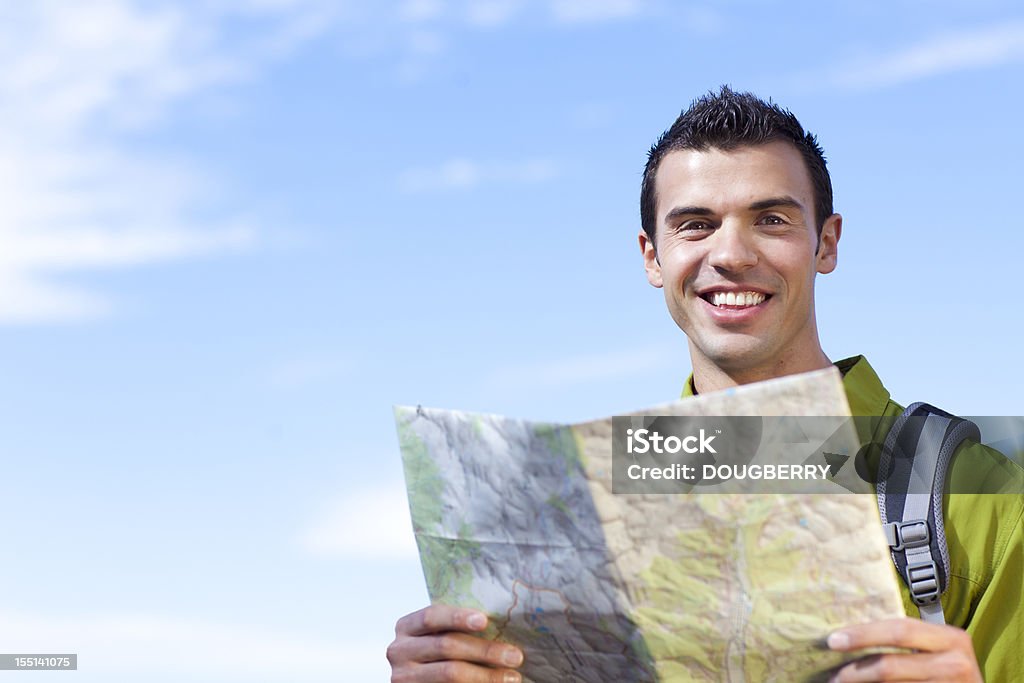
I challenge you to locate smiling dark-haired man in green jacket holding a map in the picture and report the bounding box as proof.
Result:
[388,88,1024,683]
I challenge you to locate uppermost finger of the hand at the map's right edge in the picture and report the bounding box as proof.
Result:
[828,617,974,652]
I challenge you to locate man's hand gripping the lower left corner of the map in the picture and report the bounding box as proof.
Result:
[387,605,522,683]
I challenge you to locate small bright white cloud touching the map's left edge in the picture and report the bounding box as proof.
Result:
[300,483,417,559]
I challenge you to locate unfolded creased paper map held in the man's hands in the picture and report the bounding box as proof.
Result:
[395,369,903,683]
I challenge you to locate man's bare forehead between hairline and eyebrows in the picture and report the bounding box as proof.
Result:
[654,141,814,222]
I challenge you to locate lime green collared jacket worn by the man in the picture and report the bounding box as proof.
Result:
[683,356,1024,683]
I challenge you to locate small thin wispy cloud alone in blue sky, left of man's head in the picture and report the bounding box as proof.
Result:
[398,159,559,193]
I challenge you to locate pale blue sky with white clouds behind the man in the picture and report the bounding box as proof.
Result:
[6,0,1024,682]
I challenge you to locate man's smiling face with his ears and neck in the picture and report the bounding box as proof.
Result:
[640,141,842,381]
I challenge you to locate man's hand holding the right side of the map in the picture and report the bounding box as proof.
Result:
[828,618,981,683]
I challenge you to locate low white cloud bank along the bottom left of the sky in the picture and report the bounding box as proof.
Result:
[0,611,386,681]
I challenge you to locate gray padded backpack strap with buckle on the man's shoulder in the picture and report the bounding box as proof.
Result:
[878,403,981,624]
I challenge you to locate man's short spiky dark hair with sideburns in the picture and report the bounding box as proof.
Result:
[640,85,833,243]
